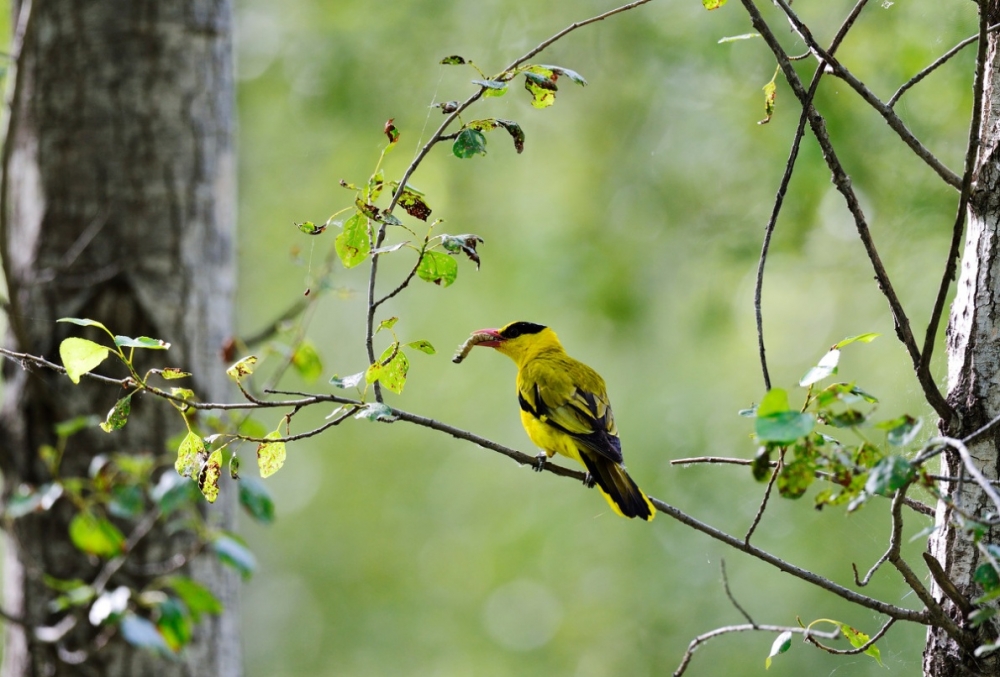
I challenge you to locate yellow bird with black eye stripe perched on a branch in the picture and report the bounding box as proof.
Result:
[470,322,656,520]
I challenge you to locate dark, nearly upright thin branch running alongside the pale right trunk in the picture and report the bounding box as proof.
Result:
[920,11,995,390]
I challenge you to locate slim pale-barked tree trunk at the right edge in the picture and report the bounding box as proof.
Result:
[924,0,1000,677]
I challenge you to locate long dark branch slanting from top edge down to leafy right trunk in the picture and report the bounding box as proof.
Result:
[742,0,952,420]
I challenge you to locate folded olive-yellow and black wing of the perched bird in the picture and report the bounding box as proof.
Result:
[518,380,622,463]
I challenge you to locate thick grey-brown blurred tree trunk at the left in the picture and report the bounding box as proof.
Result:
[0,0,242,677]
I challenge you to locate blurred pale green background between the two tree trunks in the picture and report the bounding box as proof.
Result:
[0,0,975,677]
